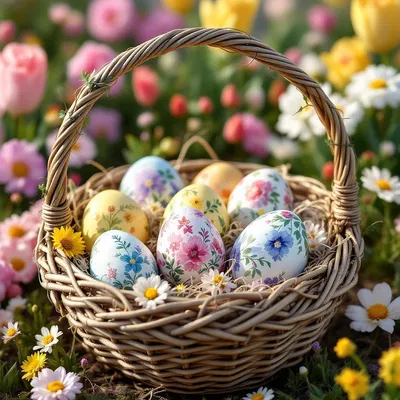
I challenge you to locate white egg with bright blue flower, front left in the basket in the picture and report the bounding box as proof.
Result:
[90,230,158,289]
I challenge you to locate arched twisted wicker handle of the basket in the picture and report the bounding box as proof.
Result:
[42,28,359,231]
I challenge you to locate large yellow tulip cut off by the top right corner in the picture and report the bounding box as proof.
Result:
[351,0,400,53]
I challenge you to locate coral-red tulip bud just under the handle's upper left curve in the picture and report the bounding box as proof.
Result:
[132,66,161,107]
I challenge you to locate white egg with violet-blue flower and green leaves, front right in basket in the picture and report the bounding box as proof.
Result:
[230,210,308,285]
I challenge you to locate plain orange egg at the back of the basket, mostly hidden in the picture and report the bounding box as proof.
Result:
[193,162,244,204]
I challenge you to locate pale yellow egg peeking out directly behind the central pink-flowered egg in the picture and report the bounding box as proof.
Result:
[164,183,229,233]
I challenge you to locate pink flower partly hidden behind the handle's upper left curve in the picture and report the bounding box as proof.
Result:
[67,41,124,96]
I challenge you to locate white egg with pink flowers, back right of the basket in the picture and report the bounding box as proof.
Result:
[228,168,293,228]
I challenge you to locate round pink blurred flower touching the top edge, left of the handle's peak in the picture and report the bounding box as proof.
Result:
[88,0,137,43]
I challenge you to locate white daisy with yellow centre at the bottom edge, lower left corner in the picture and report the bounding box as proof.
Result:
[31,367,83,400]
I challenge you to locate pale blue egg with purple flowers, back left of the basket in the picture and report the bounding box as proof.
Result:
[120,156,184,207]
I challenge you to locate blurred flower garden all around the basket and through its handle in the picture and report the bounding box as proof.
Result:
[0,0,400,400]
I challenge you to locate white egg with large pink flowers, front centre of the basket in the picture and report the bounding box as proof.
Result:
[157,207,225,284]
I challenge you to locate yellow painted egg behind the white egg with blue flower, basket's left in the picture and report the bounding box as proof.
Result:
[82,190,149,251]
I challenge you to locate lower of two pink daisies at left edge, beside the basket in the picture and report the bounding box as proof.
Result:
[0,243,37,283]
